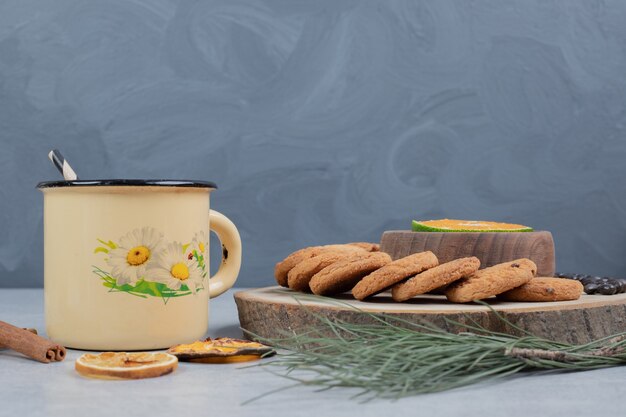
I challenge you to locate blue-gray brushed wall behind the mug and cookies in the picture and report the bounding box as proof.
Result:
[0,0,626,287]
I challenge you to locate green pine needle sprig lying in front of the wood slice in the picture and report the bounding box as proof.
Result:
[244,296,626,399]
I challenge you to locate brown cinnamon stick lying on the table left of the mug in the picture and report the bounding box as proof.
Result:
[0,321,66,363]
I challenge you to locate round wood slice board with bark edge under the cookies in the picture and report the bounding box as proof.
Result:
[235,287,626,344]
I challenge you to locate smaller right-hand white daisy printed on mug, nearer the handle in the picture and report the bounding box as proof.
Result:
[148,242,203,294]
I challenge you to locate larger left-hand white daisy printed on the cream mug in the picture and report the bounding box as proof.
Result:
[107,227,163,285]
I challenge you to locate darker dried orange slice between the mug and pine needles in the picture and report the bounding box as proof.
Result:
[167,337,276,363]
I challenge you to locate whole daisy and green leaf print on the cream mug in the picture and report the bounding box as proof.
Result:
[93,227,208,303]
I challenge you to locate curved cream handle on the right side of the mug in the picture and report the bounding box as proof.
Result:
[209,210,241,298]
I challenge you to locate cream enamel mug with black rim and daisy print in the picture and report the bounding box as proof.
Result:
[37,180,241,350]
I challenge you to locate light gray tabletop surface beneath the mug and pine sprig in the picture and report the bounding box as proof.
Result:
[0,289,626,417]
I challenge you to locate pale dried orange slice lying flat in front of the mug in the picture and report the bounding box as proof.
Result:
[75,352,178,379]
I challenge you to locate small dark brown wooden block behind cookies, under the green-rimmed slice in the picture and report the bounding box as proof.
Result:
[380,230,555,276]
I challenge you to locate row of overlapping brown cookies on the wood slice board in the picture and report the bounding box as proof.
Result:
[274,242,583,303]
